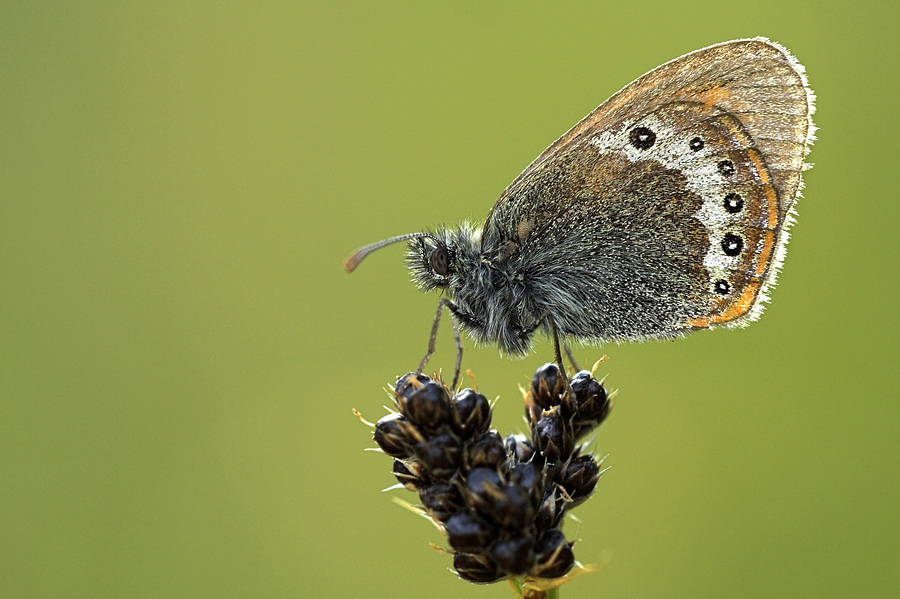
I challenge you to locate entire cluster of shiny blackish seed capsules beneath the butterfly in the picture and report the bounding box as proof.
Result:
[375,364,608,583]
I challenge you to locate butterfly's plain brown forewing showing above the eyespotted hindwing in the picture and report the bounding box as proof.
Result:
[500,37,815,210]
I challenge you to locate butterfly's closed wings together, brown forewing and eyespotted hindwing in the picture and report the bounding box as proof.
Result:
[483,38,814,340]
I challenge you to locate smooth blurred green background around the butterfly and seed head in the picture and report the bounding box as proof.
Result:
[0,0,900,598]
